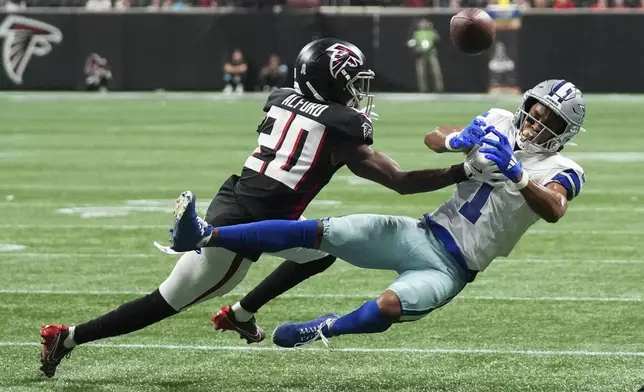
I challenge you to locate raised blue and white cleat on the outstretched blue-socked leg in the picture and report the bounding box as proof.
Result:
[170,191,213,252]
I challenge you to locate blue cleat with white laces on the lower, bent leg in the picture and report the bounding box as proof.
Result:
[273,313,340,348]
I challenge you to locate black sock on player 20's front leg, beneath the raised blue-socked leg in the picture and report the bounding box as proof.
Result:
[239,255,335,313]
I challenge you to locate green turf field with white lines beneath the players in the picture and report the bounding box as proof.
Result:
[0,94,644,392]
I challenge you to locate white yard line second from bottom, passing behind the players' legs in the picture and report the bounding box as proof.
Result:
[0,289,644,302]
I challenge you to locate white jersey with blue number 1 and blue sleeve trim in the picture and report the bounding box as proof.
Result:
[430,109,585,271]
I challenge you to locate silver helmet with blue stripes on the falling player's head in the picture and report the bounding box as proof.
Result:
[514,80,586,153]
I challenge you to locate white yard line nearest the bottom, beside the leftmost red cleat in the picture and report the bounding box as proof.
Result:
[0,341,644,357]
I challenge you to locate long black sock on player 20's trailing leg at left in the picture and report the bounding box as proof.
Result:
[74,289,179,344]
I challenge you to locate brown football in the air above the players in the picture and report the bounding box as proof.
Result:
[449,8,496,55]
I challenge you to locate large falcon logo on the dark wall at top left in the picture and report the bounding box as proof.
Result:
[0,15,63,84]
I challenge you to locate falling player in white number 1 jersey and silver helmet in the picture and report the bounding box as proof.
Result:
[171,80,585,347]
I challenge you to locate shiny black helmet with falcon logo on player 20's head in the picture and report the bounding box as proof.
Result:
[293,38,375,115]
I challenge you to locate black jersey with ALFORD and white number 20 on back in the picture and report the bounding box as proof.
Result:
[206,88,373,259]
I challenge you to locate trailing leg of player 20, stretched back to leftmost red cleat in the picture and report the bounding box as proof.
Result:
[41,248,254,377]
